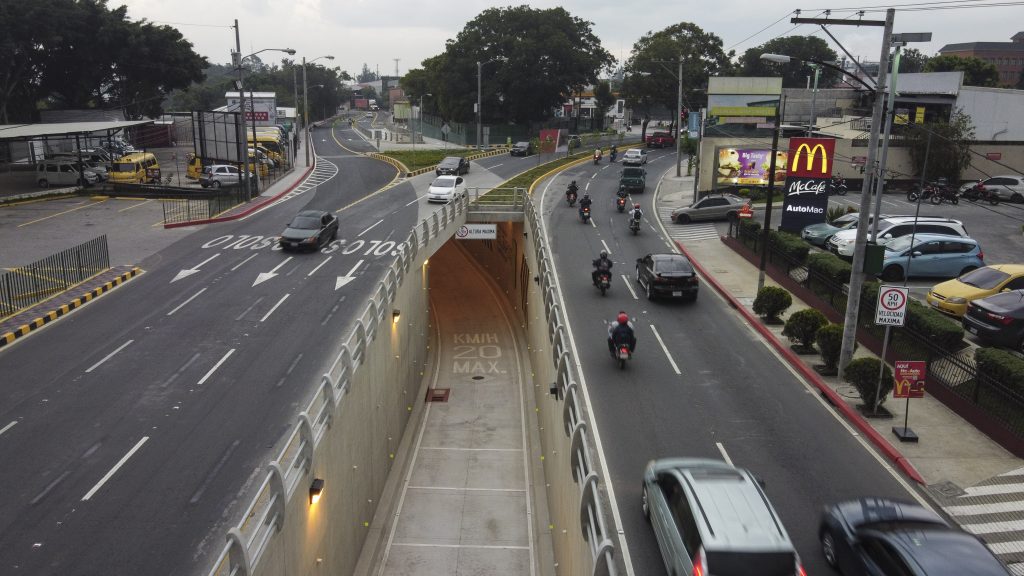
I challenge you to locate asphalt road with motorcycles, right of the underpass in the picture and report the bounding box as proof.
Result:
[535,152,925,576]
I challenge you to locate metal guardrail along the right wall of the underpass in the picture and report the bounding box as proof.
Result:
[524,194,618,576]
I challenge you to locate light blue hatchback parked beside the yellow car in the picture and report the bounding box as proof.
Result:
[881,234,985,282]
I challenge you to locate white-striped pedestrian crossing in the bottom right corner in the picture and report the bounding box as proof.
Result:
[940,468,1024,576]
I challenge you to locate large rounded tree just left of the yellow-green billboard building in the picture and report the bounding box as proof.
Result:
[622,23,733,137]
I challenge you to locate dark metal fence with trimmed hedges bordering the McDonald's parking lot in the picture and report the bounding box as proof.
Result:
[729,223,1024,439]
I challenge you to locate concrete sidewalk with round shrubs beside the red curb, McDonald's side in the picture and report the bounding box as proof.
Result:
[655,171,1024,573]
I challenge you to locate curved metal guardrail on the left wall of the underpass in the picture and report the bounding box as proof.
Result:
[209,196,470,576]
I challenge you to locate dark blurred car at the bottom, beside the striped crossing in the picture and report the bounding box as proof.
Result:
[818,497,1009,576]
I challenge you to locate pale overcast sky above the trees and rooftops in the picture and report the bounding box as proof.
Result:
[117,0,1024,76]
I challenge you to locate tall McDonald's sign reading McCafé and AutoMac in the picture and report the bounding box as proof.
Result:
[779,138,836,234]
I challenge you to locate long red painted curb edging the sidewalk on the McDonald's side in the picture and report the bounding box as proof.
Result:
[675,240,926,485]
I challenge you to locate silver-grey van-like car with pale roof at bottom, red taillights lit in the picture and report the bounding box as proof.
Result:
[641,458,805,576]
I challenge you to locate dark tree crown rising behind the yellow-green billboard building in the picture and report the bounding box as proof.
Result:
[738,36,840,88]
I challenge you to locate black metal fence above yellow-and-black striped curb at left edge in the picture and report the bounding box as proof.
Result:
[0,235,111,318]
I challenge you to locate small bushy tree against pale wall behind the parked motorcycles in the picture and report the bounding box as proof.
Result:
[906,109,974,182]
